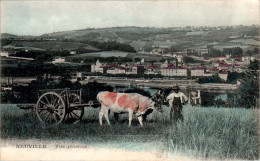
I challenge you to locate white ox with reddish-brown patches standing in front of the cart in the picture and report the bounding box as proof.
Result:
[97,91,161,126]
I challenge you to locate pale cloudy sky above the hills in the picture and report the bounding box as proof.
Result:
[0,0,260,35]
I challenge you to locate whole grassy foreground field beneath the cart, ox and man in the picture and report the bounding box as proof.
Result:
[1,105,260,159]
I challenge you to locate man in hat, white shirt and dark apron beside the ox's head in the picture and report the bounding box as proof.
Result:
[166,85,188,124]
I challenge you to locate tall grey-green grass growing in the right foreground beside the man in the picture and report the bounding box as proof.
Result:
[168,107,260,159]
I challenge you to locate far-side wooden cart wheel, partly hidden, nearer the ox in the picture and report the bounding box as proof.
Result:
[65,93,84,124]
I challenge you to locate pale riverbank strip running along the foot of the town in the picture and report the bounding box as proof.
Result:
[1,77,238,93]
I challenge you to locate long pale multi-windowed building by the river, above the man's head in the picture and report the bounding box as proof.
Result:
[161,67,188,76]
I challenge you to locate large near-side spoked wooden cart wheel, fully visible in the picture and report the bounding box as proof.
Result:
[36,92,66,125]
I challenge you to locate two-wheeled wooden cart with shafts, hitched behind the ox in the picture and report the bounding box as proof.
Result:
[18,88,99,126]
